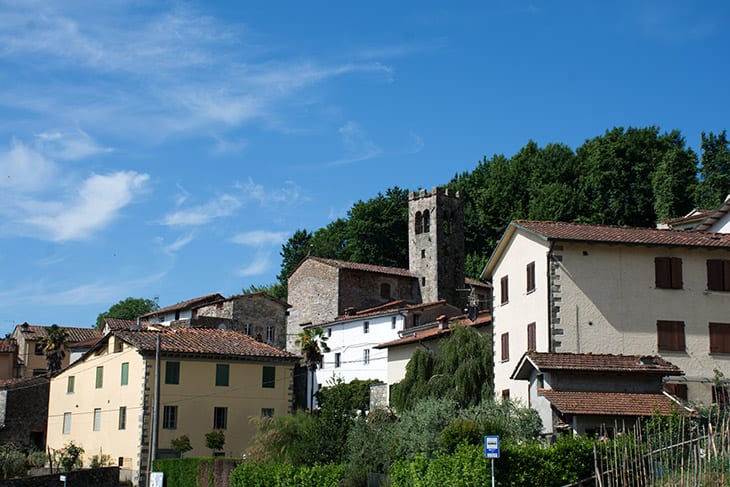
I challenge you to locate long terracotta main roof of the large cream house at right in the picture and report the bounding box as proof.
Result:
[512,220,730,248]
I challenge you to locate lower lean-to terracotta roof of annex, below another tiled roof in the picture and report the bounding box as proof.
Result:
[538,389,678,416]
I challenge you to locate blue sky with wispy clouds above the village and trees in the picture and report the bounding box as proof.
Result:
[0,0,730,335]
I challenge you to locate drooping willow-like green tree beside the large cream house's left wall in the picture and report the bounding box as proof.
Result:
[391,326,493,410]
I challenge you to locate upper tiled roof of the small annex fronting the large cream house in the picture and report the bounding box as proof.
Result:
[512,352,683,379]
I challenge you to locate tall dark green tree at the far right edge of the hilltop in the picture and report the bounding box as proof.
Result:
[696,130,730,208]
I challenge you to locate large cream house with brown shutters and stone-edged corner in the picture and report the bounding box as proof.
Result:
[482,221,730,404]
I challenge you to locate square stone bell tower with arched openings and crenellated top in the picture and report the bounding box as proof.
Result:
[408,188,466,307]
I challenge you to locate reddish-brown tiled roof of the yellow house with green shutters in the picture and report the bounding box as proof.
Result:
[113,328,299,361]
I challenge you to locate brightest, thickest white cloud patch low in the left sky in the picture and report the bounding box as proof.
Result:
[24,171,149,242]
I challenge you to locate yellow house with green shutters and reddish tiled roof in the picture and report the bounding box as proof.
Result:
[47,328,299,485]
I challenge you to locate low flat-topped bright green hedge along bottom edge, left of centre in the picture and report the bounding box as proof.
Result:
[230,462,344,487]
